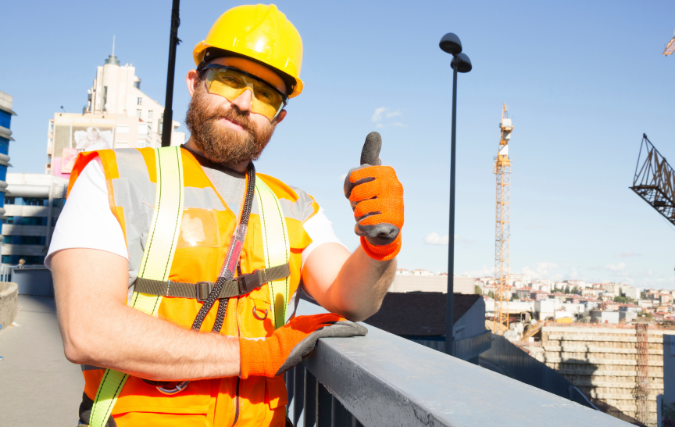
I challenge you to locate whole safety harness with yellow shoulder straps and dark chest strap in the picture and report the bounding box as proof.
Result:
[86,147,290,427]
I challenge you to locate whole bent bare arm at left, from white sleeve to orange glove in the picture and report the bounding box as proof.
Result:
[51,249,240,380]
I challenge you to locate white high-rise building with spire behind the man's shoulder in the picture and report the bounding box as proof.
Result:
[46,46,185,177]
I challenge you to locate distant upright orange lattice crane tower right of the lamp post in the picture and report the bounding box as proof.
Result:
[492,104,513,335]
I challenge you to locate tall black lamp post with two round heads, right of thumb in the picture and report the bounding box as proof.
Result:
[439,33,472,356]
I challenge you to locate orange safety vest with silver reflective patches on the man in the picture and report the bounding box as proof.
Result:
[68,148,319,427]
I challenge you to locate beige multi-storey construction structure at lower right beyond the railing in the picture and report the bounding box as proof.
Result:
[524,319,675,427]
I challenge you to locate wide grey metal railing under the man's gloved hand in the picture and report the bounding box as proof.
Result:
[286,301,630,427]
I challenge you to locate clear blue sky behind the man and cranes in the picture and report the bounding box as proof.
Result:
[0,0,675,289]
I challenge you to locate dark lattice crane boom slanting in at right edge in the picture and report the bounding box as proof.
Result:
[630,133,675,225]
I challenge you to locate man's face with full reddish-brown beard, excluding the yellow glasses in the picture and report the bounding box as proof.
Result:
[185,58,281,165]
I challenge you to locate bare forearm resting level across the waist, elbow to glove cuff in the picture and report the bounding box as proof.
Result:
[60,300,239,380]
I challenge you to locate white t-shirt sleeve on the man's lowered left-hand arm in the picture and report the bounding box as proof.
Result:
[45,159,129,268]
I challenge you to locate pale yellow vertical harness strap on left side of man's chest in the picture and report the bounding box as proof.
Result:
[89,147,184,427]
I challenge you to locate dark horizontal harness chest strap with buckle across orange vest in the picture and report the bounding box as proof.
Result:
[135,263,291,301]
